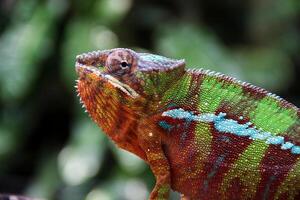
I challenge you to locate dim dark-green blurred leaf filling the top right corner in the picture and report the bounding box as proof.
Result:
[247,0,300,52]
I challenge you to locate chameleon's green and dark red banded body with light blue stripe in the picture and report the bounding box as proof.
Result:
[155,70,300,199]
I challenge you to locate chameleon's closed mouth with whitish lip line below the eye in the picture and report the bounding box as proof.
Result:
[75,62,139,98]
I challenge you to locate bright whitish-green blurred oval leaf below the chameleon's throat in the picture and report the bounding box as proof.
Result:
[58,120,106,185]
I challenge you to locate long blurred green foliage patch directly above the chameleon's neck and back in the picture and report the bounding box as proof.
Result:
[156,24,293,91]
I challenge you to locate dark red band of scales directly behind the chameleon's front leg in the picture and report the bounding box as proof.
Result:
[155,111,198,191]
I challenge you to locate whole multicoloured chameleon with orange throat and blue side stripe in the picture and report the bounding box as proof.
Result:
[75,48,300,200]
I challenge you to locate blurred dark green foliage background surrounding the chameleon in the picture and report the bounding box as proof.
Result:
[0,0,300,200]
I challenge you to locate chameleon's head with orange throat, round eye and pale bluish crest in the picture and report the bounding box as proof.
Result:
[75,48,185,138]
